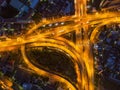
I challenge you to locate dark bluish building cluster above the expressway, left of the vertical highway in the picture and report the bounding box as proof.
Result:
[0,0,74,36]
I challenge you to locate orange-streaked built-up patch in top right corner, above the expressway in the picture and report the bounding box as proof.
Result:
[87,0,120,13]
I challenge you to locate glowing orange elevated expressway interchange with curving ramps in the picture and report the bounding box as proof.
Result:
[0,0,120,90]
